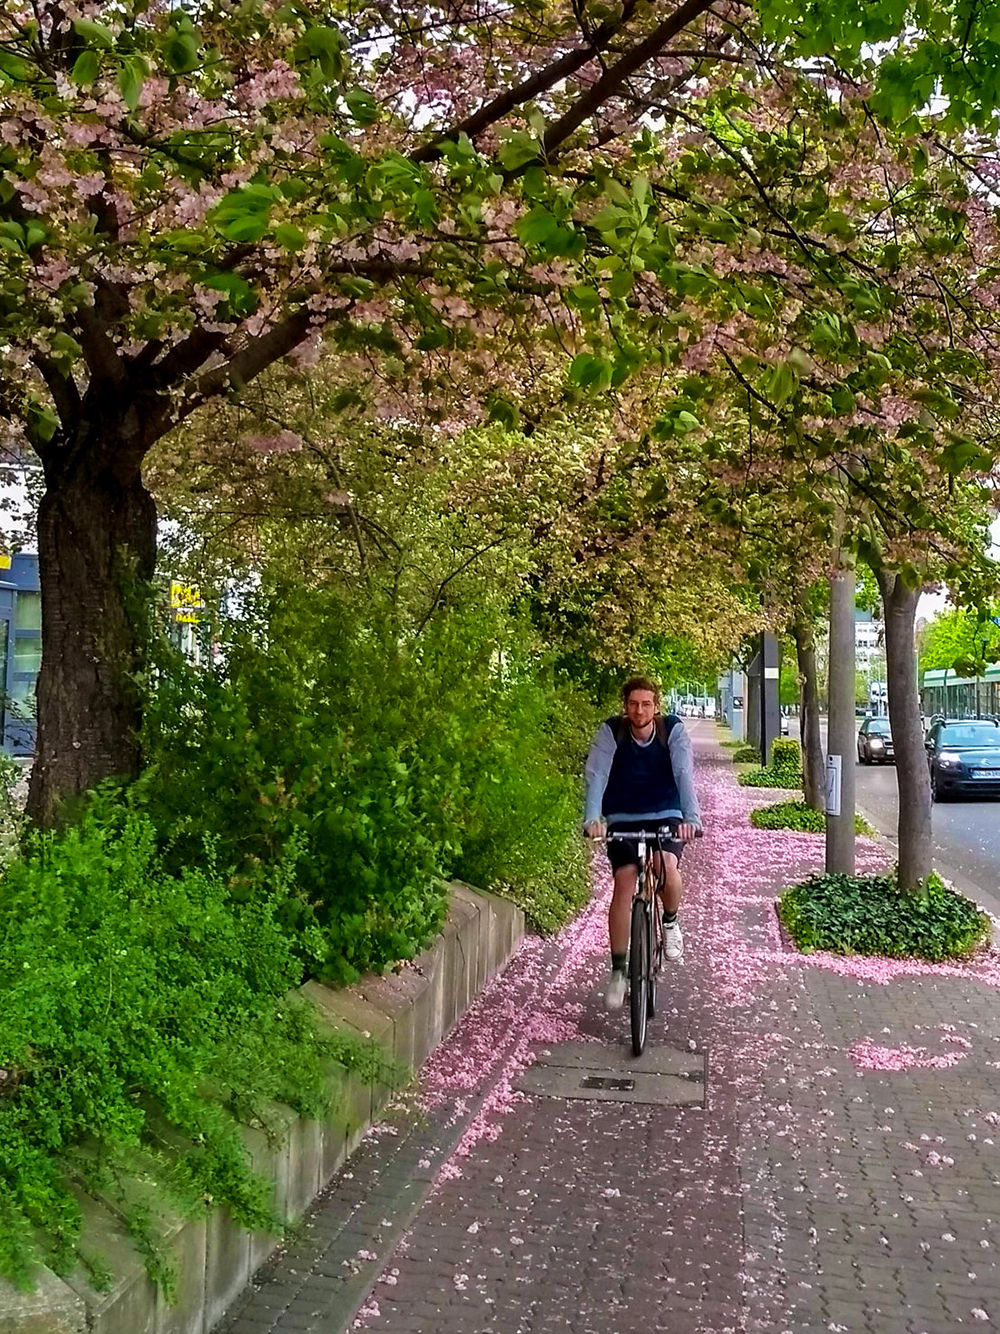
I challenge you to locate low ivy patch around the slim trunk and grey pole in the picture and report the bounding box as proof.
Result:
[777,875,989,963]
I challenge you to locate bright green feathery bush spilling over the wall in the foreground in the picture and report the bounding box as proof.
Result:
[0,794,373,1283]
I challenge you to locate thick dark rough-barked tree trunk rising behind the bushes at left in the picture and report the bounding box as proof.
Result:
[28,464,156,827]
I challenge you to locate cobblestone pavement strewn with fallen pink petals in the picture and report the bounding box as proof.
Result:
[223,723,1000,1334]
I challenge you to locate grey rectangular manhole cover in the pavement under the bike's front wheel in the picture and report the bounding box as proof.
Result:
[513,1042,705,1107]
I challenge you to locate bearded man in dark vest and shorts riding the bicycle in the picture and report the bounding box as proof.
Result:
[584,676,701,1010]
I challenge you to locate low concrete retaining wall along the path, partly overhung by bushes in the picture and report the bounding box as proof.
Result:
[0,883,524,1334]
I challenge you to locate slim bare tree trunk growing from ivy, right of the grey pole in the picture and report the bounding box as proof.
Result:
[876,571,932,890]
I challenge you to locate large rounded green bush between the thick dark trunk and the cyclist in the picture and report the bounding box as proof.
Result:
[143,586,593,982]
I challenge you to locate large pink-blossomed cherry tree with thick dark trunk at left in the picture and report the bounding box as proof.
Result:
[0,0,996,823]
